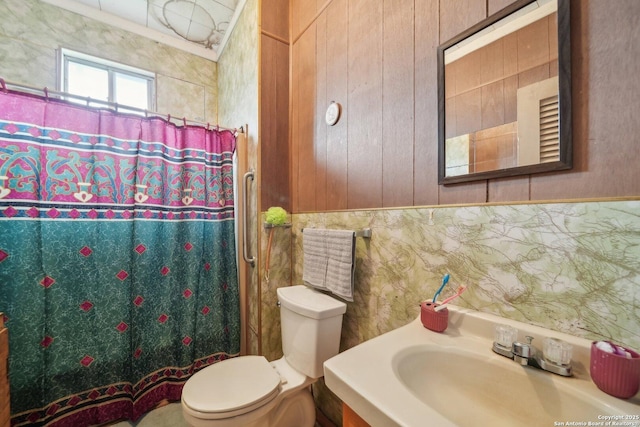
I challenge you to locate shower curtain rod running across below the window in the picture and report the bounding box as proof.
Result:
[0,77,244,133]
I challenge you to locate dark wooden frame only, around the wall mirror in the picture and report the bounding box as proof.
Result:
[438,0,573,185]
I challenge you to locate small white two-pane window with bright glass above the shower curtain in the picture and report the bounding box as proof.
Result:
[60,49,155,113]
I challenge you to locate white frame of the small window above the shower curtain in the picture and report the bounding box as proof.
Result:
[58,48,156,111]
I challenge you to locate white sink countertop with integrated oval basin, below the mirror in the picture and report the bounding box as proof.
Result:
[324,307,640,427]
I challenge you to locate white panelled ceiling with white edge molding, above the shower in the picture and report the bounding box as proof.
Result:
[43,0,246,61]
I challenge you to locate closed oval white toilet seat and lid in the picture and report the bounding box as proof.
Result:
[182,356,280,419]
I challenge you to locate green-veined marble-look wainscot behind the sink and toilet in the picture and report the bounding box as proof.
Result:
[264,200,640,421]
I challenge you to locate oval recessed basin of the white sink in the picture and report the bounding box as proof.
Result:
[393,345,604,426]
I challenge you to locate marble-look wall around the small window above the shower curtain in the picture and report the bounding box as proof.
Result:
[0,0,218,126]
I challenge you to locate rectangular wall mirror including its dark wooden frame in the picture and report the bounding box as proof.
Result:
[438,0,572,184]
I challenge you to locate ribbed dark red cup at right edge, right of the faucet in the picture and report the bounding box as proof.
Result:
[590,341,640,399]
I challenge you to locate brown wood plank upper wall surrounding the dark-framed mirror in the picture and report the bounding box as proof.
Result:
[290,0,640,212]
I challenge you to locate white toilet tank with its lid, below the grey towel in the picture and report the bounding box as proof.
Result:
[277,285,347,378]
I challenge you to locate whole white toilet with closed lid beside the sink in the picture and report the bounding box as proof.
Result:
[182,285,347,427]
